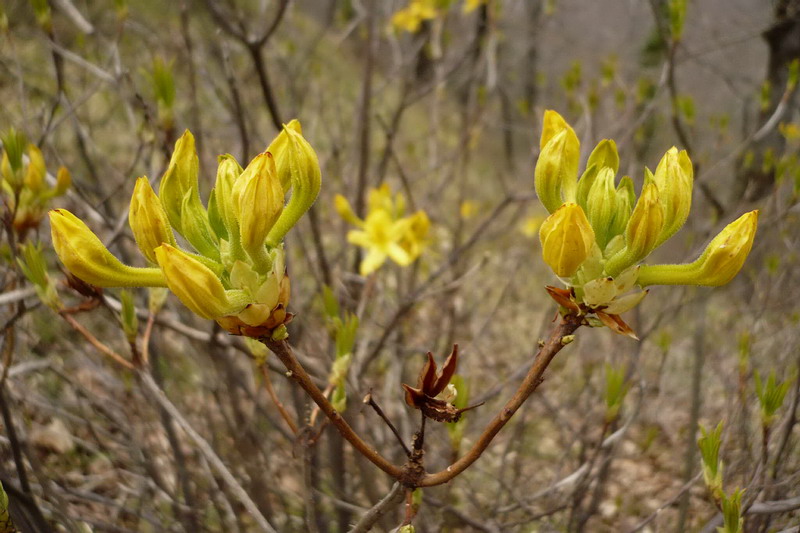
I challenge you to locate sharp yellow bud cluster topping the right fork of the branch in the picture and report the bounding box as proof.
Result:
[535,111,758,331]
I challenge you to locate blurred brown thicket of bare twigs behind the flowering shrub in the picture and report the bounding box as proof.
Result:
[0,0,800,532]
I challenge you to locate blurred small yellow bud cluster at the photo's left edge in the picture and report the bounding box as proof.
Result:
[0,129,72,240]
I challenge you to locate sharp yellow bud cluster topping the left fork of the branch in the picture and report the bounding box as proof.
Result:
[50,121,320,337]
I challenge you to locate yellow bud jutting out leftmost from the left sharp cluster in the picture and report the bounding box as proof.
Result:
[50,209,166,287]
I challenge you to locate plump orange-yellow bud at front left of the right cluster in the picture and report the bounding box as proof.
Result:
[539,203,594,278]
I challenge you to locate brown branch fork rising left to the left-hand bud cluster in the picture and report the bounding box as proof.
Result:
[259,337,403,479]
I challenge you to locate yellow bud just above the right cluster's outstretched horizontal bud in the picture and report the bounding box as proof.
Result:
[606,183,664,276]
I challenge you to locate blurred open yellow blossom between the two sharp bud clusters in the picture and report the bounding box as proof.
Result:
[334,183,431,276]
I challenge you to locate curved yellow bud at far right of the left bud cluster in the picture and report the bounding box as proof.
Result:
[267,126,322,247]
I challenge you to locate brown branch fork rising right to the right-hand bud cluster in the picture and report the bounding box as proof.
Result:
[417,315,582,487]
